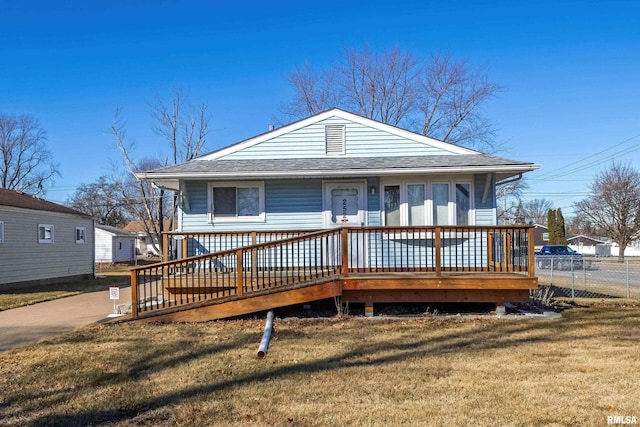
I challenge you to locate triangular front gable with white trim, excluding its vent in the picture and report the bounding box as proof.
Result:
[201,108,480,160]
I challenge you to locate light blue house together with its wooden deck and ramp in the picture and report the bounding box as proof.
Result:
[132,109,539,320]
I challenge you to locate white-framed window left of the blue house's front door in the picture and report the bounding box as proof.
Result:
[209,182,264,222]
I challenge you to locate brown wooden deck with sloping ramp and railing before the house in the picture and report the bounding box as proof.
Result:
[132,227,538,321]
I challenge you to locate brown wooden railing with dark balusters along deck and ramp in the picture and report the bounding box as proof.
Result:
[131,226,535,317]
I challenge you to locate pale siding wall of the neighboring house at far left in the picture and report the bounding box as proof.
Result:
[0,206,94,285]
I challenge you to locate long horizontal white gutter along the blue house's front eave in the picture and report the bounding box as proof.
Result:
[136,165,540,183]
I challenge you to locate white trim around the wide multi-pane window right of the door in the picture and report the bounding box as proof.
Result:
[380,179,476,227]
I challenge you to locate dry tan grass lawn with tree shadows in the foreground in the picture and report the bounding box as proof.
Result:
[0,305,640,426]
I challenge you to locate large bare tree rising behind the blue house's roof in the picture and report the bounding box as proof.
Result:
[282,47,501,151]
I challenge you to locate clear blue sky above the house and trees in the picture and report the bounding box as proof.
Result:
[0,0,640,217]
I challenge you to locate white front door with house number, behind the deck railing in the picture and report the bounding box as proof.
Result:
[323,181,368,268]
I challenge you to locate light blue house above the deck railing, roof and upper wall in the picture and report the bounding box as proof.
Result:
[138,109,539,231]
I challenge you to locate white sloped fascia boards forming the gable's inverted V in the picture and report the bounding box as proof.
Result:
[196,108,483,160]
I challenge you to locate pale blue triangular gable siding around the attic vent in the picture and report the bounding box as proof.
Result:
[220,117,453,160]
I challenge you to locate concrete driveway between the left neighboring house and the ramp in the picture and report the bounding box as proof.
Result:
[0,287,131,352]
